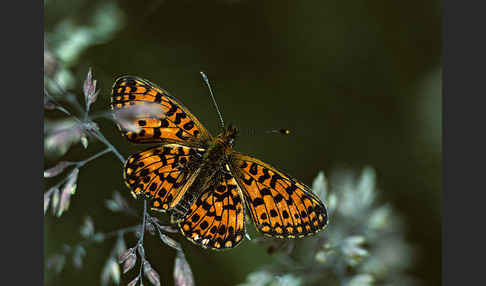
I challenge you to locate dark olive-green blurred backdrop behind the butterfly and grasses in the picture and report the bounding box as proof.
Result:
[44,1,442,285]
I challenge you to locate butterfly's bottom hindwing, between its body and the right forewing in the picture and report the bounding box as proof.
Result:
[179,168,245,250]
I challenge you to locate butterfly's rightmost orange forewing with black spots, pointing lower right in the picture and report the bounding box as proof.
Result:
[230,152,327,238]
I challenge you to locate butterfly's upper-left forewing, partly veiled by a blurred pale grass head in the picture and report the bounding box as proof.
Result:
[111,76,211,146]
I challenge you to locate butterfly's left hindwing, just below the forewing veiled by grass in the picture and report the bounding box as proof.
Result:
[124,144,205,211]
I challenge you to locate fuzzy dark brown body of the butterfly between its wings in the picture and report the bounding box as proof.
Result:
[172,126,238,221]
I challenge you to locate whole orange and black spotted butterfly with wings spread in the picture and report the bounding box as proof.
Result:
[111,74,327,249]
